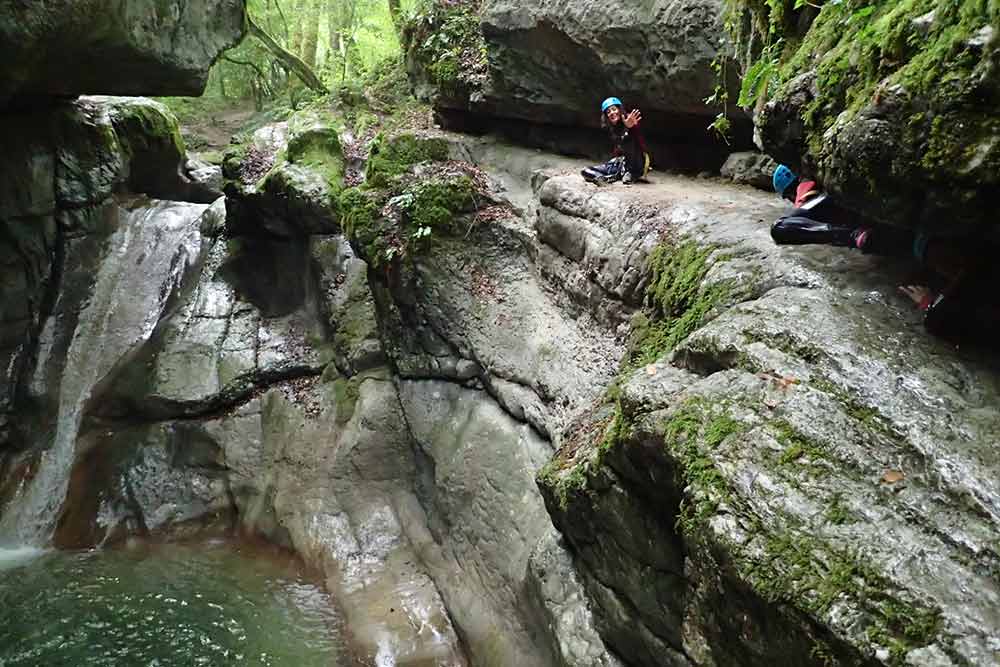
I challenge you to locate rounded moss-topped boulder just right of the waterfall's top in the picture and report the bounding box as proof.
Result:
[223,111,344,237]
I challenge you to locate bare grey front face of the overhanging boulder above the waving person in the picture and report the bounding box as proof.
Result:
[482,0,736,125]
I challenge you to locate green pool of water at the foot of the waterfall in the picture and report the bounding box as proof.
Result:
[0,541,351,667]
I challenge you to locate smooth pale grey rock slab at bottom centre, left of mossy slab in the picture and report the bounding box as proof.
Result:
[392,381,552,666]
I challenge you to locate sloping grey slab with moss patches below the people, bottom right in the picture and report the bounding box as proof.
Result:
[539,168,1000,665]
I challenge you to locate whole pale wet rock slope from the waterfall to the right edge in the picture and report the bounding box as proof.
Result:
[0,107,1000,666]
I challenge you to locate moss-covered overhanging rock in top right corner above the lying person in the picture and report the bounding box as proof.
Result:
[744,0,1000,233]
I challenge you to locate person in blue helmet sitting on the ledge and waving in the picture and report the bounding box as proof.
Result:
[580,97,650,185]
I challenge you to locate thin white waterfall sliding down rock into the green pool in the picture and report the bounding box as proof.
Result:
[0,200,208,548]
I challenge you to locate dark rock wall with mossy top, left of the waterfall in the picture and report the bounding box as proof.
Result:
[0,97,204,448]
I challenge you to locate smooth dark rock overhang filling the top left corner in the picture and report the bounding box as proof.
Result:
[0,0,246,108]
